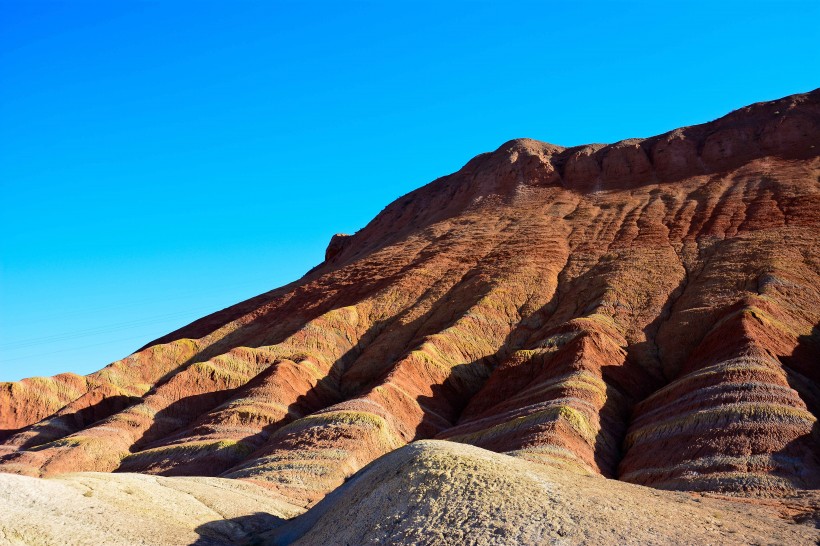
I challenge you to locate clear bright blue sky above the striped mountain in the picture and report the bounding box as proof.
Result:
[0,0,820,381]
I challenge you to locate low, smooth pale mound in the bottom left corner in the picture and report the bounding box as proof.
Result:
[0,472,302,546]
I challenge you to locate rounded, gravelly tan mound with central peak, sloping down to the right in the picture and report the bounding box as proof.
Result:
[266,440,820,546]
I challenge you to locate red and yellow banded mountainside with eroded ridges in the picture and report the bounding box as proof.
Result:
[0,91,820,536]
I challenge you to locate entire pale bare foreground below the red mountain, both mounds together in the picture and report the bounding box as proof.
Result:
[0,440,820,546]
